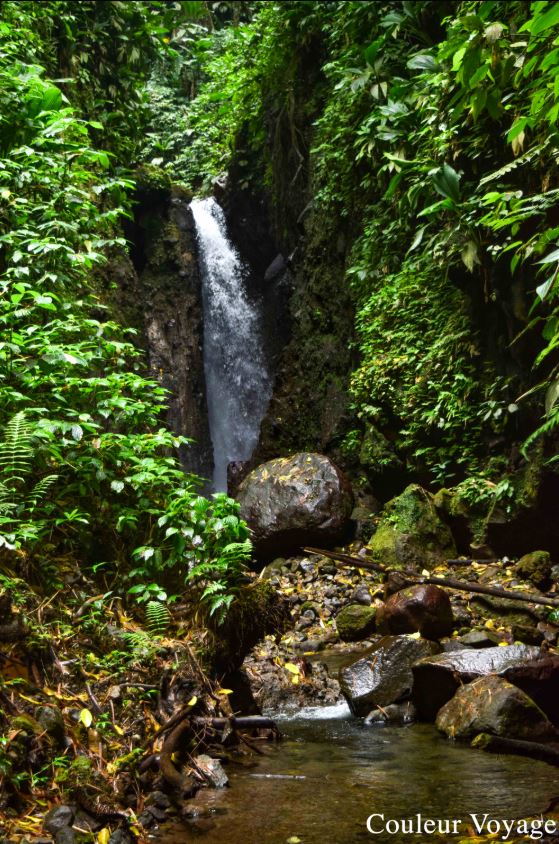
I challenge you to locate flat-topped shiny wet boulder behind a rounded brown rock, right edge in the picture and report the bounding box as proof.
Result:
[412,645,559,723]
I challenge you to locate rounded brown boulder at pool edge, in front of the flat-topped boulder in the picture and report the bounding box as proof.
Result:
[436,674,557,741]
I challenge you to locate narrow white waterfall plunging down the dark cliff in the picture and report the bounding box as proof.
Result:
[191,198,272,490]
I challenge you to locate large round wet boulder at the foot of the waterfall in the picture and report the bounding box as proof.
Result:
[237,452,353,556]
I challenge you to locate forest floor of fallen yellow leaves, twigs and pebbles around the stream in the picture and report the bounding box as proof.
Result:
[0,543,559,844]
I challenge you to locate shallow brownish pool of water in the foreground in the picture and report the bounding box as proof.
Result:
[154,705,559,844]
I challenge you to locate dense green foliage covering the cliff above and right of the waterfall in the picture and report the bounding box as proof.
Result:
[146,2,559,481]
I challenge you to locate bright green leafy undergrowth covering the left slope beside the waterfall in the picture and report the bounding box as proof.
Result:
[0,2,249,612]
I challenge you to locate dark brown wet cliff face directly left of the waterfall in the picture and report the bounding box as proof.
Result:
[118,178,213,477]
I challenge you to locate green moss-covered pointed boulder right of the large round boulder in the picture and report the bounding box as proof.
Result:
[369,484,456,568]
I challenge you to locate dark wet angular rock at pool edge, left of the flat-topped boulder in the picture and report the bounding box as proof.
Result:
[340,636,438,716]
